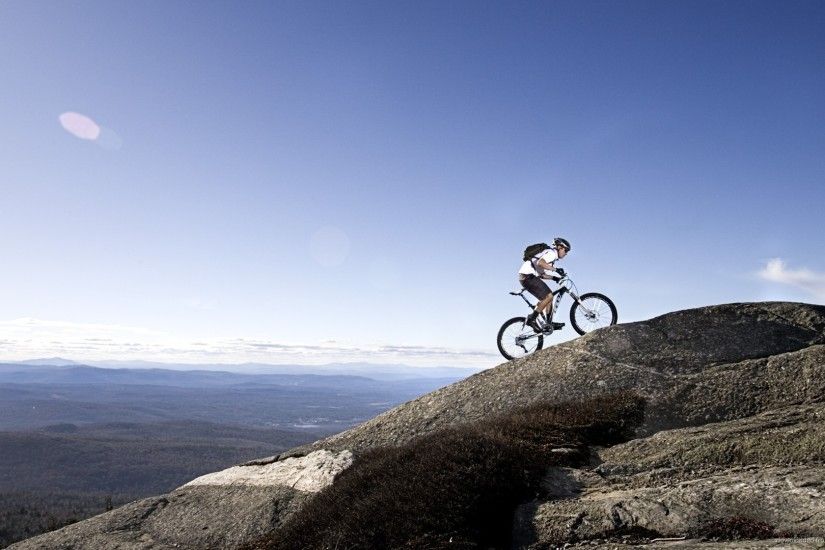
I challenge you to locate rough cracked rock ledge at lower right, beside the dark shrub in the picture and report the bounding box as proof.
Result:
[516,404,825,548]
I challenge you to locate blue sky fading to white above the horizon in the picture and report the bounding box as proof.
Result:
[0,0,825,366]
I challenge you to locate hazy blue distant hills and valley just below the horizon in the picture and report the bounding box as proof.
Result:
[0,360,475,432]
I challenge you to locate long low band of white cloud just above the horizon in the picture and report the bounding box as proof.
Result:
[0,318,500,367]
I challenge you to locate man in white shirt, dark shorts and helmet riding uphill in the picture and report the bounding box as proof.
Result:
[518,237,570,332]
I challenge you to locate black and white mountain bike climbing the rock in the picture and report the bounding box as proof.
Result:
[497,274,619,360]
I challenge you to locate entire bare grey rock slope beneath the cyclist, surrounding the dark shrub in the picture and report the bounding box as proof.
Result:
[13,302,825,549]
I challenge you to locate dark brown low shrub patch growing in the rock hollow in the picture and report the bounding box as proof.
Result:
[245,393,644,550]
